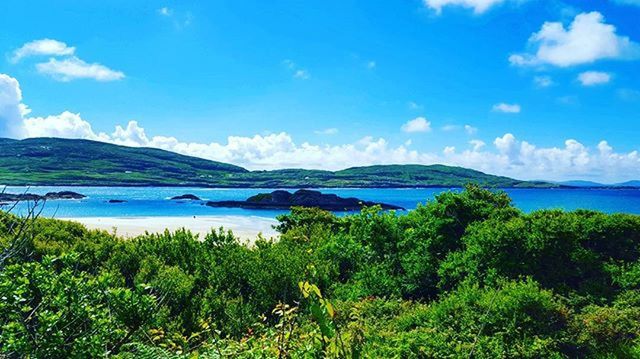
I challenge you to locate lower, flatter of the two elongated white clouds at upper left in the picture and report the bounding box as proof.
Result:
[36,56,124,82]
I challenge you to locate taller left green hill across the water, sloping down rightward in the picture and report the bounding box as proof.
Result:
[0,138,247,185]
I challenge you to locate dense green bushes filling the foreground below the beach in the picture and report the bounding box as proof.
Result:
[0,187,640,358]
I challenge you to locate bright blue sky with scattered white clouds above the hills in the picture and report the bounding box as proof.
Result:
[0,0,640,182]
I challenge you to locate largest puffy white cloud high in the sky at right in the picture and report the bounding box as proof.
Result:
[509,11,640,67]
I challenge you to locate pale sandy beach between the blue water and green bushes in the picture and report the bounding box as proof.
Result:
[59,216,278,241]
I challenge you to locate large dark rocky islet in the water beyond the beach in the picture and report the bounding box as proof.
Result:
[206,189,404,211]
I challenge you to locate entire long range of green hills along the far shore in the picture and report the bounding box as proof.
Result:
[0,138,559,188]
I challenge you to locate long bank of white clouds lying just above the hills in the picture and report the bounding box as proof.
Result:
[0,74,640,182]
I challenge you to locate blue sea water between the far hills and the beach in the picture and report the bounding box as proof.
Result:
[6,187,640,218]
